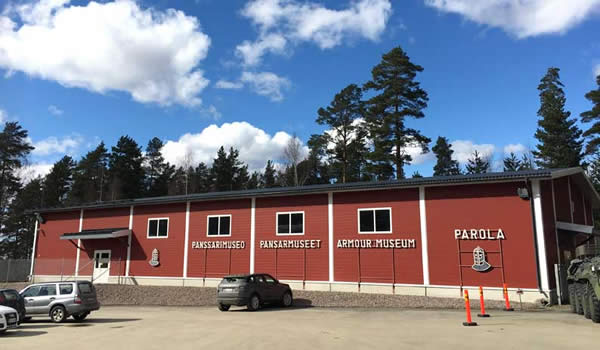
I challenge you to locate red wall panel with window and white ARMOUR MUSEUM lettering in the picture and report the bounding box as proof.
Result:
[333,188,423,284]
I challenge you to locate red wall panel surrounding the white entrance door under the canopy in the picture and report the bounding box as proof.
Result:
[79,207,129,276]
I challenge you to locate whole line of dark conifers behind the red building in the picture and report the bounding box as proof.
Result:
[0,47,600,257]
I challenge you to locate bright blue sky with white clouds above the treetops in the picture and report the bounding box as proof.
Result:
[0,0,600,179]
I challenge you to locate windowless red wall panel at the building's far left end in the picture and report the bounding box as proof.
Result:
[34,210,80,276]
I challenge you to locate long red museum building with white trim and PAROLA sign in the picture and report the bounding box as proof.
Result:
[31,168,600,301]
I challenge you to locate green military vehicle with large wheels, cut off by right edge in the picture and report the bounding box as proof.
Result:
[567,243,600,323]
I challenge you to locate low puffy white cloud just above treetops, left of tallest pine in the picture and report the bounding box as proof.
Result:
[162,122,308,171]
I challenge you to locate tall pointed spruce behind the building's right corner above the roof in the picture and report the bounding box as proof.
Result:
[533,68,583,168]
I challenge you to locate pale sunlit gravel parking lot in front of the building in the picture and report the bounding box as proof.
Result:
[0,306,600,350]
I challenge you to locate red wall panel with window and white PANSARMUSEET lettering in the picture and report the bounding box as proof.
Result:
[255,194,329,281]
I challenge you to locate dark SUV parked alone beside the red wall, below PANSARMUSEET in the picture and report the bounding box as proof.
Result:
[217,273,293,311]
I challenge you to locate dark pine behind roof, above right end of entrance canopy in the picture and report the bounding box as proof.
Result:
[109,136,144,199]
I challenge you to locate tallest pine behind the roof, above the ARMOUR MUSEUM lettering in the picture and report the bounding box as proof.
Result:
[364,47,431,180]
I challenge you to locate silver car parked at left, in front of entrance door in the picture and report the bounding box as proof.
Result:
[20,281,100,323]
